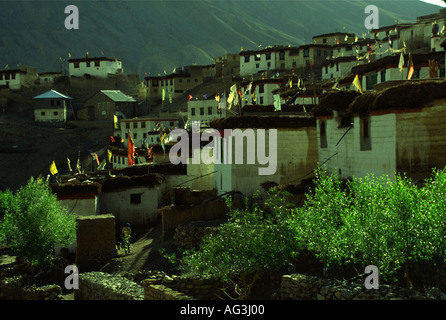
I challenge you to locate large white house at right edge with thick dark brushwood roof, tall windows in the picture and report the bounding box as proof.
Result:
[314,80,446,180]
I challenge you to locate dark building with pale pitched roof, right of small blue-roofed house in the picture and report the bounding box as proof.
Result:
[77,90,138,120]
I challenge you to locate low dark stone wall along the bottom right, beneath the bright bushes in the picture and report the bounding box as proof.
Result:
[280,274,446,300]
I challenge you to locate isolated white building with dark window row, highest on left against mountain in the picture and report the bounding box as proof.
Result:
[68,54,124,78]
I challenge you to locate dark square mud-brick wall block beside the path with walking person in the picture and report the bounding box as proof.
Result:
[76,214,118,272]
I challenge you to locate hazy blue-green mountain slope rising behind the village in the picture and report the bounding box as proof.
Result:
[0,0,438,76]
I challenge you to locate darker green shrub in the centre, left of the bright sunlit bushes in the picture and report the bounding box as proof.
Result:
[180,192,299,297]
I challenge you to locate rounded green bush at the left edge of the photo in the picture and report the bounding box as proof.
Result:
[0,178,76,265]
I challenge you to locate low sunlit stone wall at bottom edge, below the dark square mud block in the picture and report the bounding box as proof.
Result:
[74,272,144,300]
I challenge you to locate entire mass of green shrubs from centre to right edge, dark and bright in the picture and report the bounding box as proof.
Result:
[181,169,446,296]
